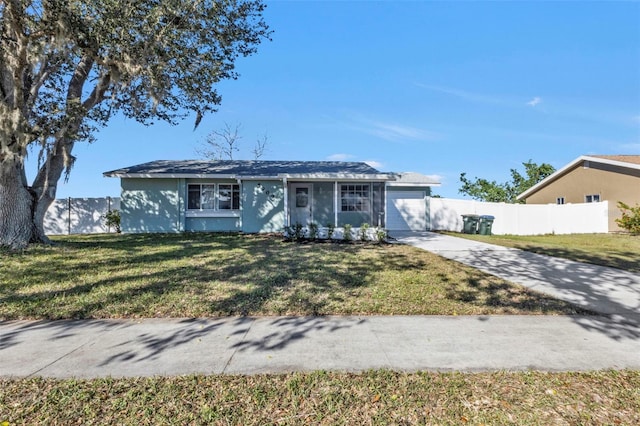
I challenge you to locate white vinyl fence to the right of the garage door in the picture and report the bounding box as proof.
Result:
[428,198,609,235]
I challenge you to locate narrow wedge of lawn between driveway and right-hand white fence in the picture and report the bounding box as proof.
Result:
[447,232,640,273]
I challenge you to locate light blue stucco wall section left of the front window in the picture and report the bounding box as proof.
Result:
[120,178,182,233]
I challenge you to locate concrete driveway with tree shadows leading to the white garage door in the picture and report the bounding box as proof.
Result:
[393,232,640,322]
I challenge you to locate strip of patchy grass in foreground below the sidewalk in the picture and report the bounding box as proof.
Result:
[0,370,640,425]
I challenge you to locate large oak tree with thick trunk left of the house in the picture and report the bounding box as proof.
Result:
[0,0,269,249]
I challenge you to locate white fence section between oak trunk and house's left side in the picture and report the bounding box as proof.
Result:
[44,197,120,235]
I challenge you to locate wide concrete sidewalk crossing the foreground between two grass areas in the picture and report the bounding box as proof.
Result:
[0,316,640,378]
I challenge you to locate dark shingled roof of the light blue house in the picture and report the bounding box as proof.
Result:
[104,160,394,180]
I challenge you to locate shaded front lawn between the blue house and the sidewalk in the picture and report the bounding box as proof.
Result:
[0,233,584,320]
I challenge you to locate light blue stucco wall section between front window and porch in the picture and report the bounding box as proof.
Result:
[241,180,285,233]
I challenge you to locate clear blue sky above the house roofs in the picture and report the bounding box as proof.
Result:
[28,1,640,198]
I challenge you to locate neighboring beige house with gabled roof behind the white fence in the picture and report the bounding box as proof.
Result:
[518,155,640,232]
